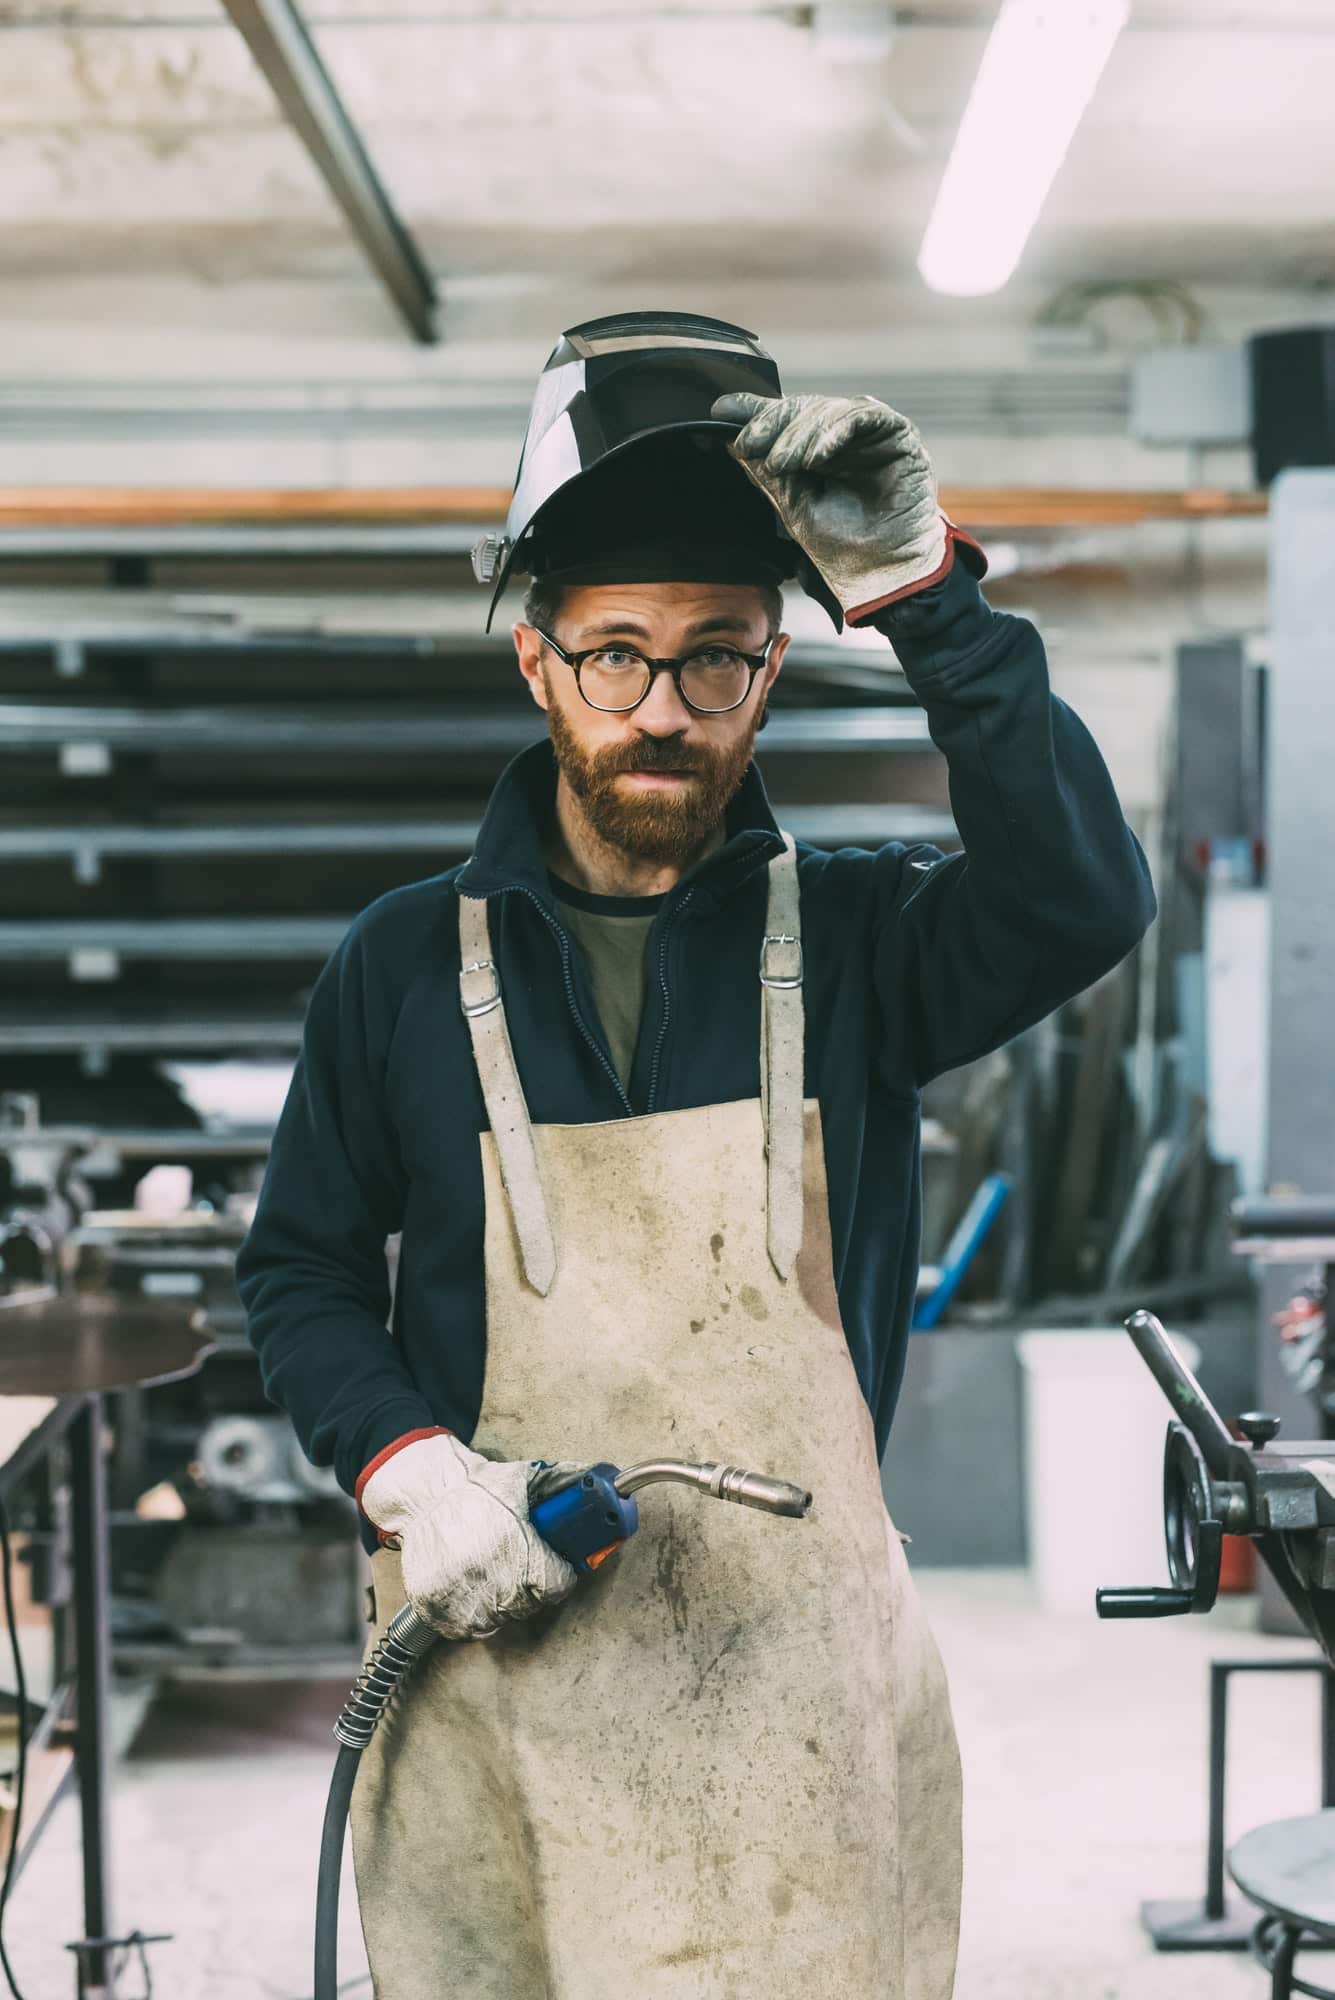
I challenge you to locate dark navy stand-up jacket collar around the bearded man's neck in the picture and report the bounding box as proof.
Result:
[456,740,783,908]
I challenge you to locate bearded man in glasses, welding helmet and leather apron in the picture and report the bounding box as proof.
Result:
[240,316,1155,2000]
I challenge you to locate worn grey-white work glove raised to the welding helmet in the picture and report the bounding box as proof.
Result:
[709,394,981,624]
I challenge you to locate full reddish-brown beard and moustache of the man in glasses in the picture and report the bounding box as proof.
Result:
[548,682,765,868]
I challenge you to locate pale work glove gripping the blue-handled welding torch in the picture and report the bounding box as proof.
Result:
[356,1430,584,1638]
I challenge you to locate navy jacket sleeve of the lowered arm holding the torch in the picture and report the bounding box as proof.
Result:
[236,920,434,1492]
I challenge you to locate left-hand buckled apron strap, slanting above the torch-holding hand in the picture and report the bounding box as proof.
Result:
[460,896,556,1298]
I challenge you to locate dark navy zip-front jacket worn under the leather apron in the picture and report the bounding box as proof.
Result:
[238,562,1155,1546]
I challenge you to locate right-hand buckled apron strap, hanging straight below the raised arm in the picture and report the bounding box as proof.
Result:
[759,834,803,1278]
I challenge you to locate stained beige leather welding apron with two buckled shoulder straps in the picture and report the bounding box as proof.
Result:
[352,842,959,2000]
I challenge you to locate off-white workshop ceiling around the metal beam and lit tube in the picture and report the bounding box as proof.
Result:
[0,0,1335,298]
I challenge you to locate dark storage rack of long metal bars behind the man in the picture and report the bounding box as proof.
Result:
[0,526,955,1088]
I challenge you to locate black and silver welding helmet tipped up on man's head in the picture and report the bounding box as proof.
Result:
[474,312,843,630]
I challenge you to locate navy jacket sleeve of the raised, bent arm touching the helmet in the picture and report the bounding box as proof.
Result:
[873,562,1157,1084]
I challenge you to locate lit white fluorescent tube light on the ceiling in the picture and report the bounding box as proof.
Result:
[917,0,1129,296]
